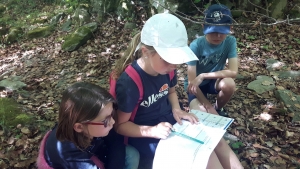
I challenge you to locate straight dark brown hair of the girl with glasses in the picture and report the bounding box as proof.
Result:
[56,82,115,149]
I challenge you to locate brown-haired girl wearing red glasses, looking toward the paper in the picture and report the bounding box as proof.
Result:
[37,82,139,169]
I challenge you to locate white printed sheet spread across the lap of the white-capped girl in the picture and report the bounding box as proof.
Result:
[153,110,233,169]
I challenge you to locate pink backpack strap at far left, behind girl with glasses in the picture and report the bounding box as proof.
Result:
[36,131,53,169]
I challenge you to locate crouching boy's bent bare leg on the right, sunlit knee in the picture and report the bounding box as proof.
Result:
[215,78,235,109]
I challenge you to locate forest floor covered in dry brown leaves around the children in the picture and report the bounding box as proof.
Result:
[0,1,300,169]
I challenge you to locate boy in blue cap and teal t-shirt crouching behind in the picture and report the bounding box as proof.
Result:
[185,4,238,116]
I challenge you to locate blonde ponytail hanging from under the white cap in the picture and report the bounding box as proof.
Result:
[113,32,156,78]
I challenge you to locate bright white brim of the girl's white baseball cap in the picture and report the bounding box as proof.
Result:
[154,46,198,64]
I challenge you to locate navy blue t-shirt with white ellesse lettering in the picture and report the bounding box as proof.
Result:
[116,61,177,125]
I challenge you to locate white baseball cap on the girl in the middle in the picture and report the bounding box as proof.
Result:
[141,13,198,64]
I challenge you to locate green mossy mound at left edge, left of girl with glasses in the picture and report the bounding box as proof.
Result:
[0,98,31,128]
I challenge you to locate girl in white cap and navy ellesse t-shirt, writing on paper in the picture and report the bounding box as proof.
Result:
[115,14,243,169]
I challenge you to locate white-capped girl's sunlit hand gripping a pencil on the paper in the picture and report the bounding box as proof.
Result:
[151,122,173,139]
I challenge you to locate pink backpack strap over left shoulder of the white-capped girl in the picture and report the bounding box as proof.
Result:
[124,65,144,145]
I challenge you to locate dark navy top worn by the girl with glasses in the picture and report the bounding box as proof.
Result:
[44,126,125,169]
